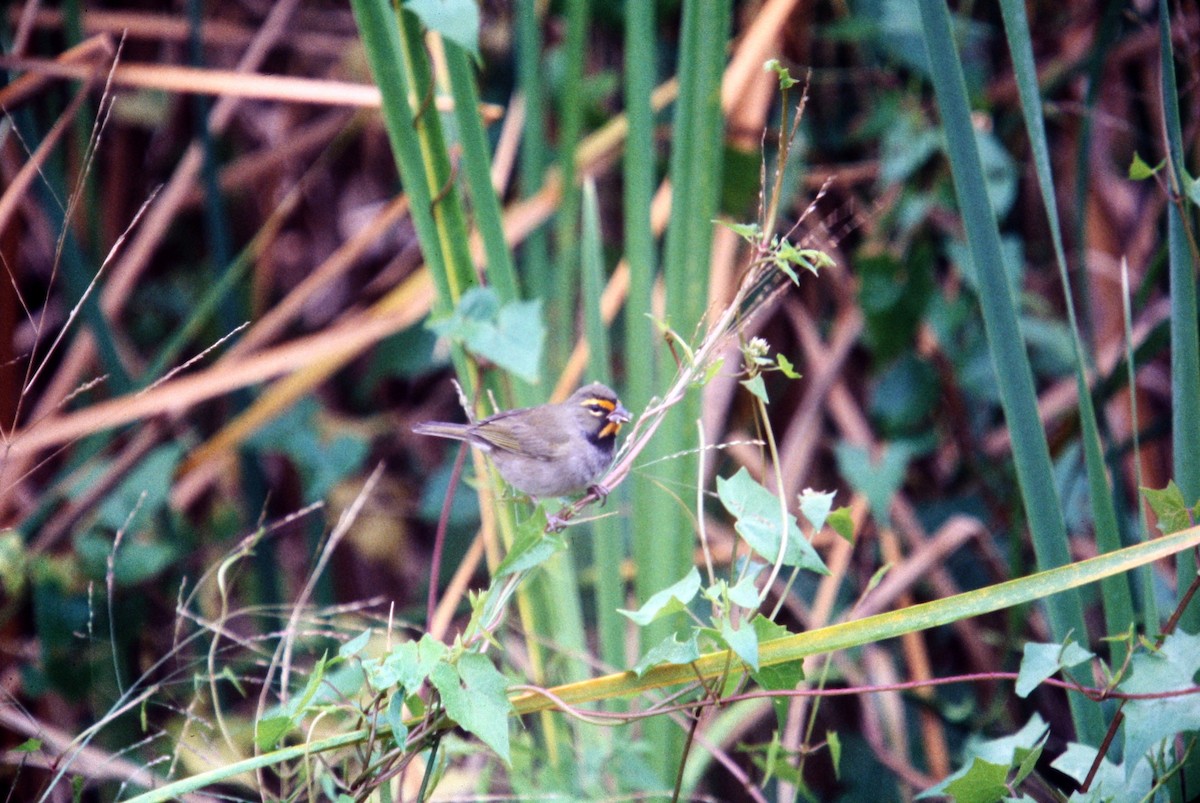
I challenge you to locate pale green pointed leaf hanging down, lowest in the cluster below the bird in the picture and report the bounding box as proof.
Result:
[430,653,512,763]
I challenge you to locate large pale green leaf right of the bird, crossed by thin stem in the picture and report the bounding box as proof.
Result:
[716,468,829,574]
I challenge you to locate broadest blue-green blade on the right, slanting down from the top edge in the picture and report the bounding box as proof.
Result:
[920,0,1104,744]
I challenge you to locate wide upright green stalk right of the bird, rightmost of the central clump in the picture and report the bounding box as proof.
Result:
[634,0,732,779]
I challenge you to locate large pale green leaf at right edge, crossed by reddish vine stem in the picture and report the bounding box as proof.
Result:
[1120,630,1200,762]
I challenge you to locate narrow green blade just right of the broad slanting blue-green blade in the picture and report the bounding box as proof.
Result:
[1001,0,1132,665]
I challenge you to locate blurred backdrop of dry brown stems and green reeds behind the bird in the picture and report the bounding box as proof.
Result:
[0,0,1200,801]
